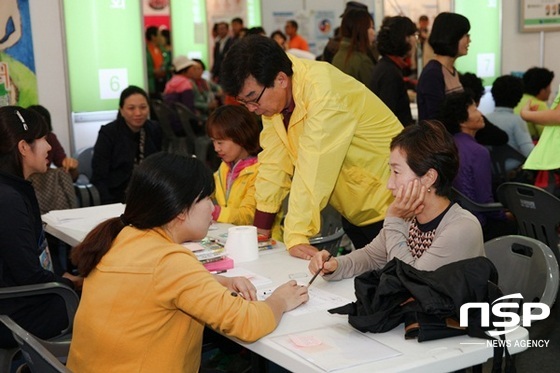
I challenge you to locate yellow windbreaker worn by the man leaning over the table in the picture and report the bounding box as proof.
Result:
[255,56,402,248]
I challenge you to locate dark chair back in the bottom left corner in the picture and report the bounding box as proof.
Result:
[0,315,70,373]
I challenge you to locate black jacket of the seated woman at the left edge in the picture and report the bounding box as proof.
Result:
[0,172,73,348]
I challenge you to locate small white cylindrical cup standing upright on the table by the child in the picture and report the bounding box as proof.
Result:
[225,225,259,263]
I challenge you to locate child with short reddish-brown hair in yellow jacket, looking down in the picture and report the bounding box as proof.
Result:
[206,105,282,240]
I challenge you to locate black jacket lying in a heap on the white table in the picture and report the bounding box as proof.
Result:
[329,257,498,336]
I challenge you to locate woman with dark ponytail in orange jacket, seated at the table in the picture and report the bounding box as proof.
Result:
[68,153,308,372]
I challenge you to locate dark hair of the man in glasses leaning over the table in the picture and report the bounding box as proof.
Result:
[220,35,294,97]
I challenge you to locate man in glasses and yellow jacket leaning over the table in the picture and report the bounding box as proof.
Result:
[221,36,402,259]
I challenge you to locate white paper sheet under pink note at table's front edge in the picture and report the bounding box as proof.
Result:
[272,324,402,372]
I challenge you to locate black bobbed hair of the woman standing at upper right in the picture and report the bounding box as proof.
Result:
[428,12,471,57]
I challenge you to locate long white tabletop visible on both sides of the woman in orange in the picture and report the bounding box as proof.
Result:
[43,204,529,372]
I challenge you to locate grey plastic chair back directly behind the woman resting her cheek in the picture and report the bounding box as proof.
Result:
[484,235,559,320]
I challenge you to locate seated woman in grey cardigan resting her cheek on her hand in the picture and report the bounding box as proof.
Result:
[309,121,485,280]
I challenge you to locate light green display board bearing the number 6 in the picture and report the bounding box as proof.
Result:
[64,0,146,112]
